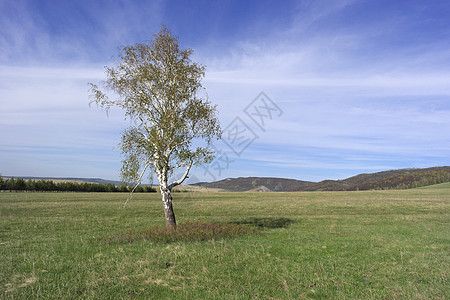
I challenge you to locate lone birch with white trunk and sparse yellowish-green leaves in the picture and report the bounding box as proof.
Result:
[89,25,221,228]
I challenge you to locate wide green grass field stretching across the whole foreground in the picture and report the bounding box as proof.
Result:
[0,184,450,299]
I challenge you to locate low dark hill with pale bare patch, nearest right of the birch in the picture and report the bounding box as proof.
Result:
[193,177,313,192]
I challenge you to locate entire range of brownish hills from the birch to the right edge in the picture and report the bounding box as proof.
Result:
[194,166,450,192]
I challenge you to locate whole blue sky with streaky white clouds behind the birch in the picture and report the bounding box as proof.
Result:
[0,0,450,181]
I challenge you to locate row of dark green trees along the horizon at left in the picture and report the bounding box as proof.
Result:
[0,176,156,193]
